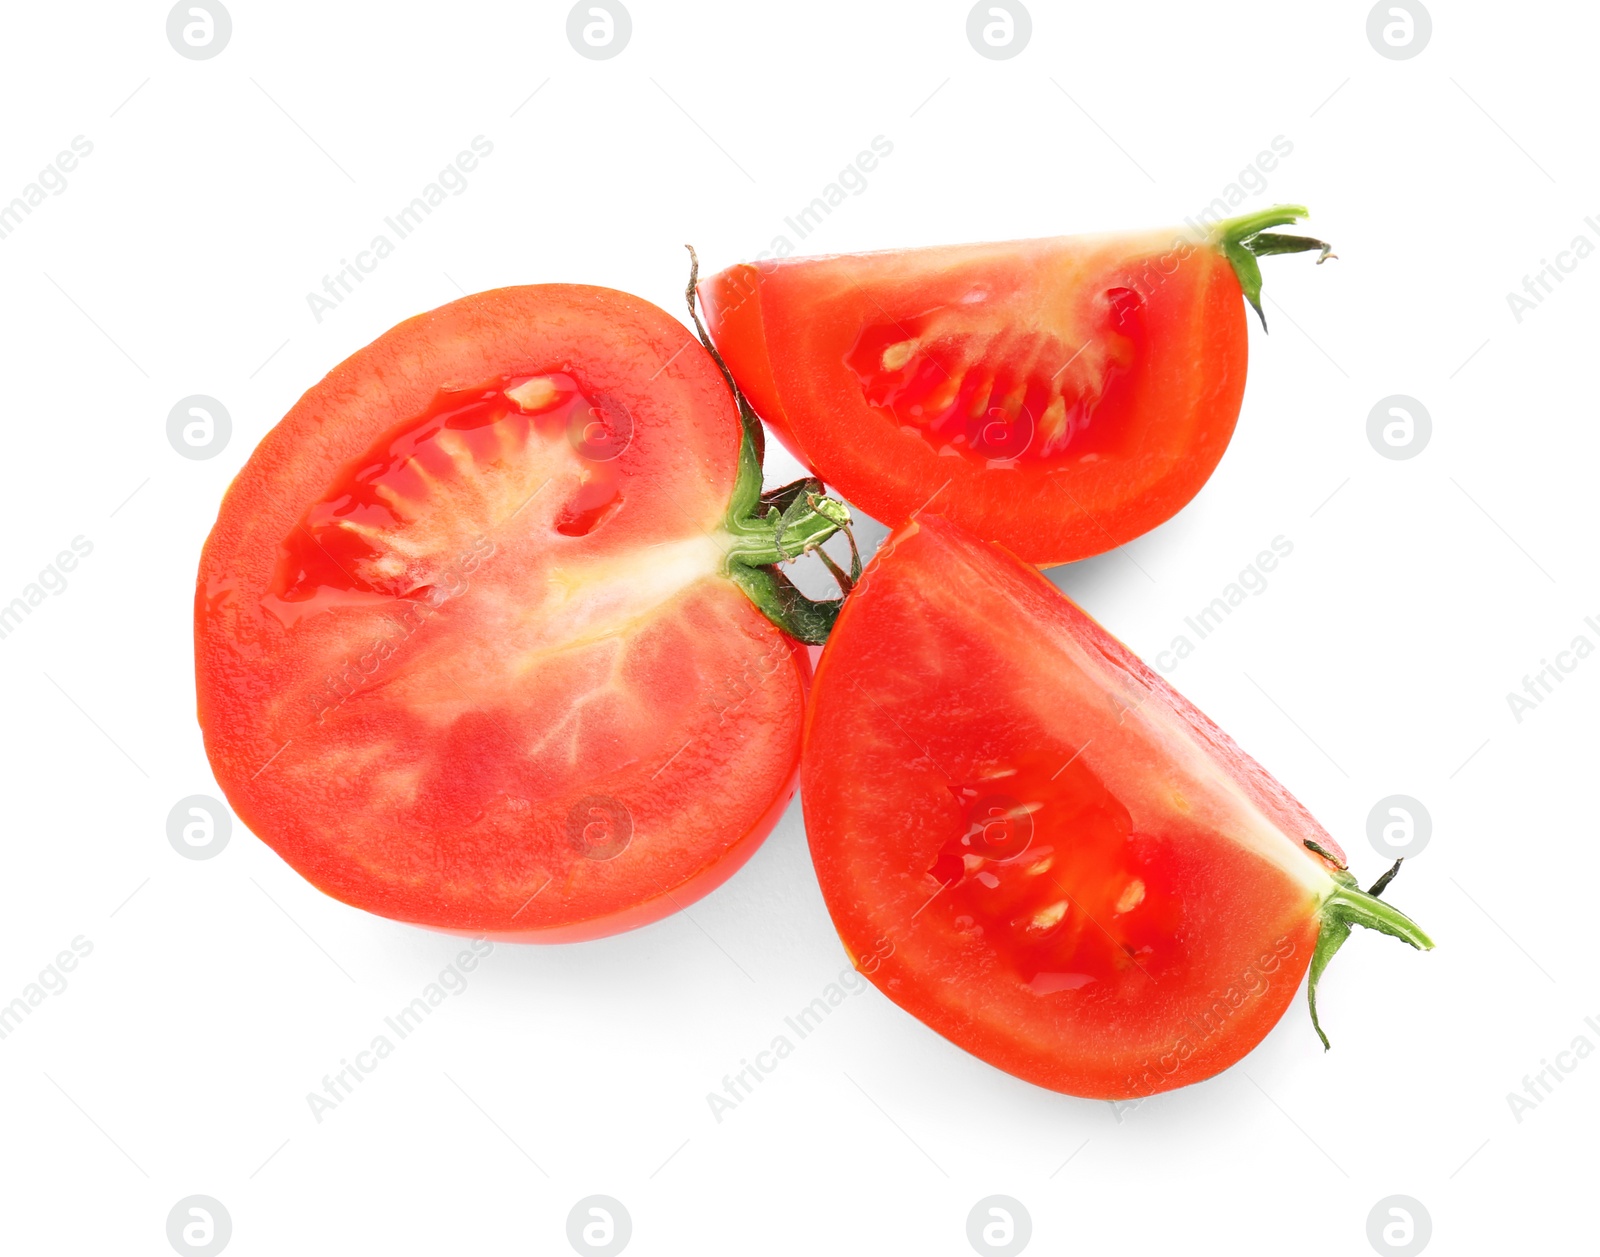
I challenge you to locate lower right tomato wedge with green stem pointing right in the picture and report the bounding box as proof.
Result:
[802,515,1432,1099]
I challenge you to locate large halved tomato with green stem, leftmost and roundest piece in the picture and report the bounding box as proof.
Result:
[195,285,848,940]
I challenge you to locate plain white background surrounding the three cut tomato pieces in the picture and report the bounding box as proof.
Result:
[0,0,1600,1257]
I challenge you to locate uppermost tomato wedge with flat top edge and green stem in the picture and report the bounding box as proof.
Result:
[701,206,1328,565]
